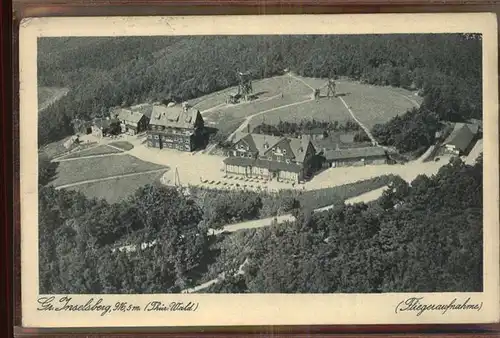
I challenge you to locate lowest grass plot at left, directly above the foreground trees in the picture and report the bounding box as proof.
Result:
[68,172,163,203]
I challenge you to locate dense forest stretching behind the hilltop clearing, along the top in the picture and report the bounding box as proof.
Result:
[38,34,482,145]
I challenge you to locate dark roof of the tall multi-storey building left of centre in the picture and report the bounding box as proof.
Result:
[149,105,200,129]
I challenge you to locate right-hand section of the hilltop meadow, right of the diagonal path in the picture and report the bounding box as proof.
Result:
[303,78,422,128]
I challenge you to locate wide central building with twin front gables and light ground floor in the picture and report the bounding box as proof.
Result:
[224,134,316,182]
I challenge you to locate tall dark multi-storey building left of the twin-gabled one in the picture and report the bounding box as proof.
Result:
[148,103,205,151]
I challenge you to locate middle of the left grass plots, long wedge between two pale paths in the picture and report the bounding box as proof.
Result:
[51,155,167,187]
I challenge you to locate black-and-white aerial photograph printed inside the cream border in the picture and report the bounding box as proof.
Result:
[17,13,498,328]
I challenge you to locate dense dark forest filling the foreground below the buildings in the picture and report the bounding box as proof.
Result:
[39,158,483,294]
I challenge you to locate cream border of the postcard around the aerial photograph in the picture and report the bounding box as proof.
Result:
[19,13,500,327]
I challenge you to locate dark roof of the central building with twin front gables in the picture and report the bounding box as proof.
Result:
[235,134,311,162]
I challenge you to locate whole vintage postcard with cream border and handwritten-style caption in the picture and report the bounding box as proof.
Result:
[20,13,500,327]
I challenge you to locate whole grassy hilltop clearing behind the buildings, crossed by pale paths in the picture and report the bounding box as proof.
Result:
[194,75,422,139]
